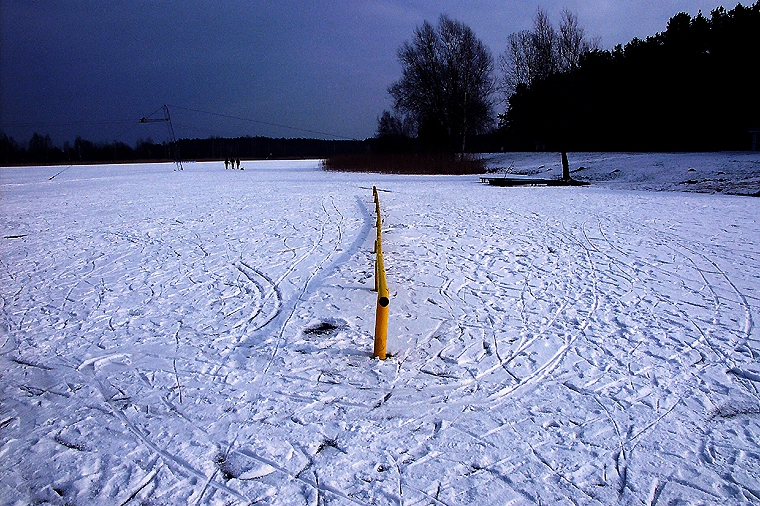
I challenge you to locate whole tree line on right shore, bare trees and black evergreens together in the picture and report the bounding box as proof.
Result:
[376,1,760,153]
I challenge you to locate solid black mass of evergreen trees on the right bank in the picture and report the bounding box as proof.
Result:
[500,2,760,151]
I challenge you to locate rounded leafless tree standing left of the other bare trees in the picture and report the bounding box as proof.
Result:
[388,15,494,152]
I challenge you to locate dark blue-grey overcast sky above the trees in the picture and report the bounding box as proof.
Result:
[0,0,751,145]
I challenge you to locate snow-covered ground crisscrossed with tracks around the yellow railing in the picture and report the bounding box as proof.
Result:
[0,154,760,505]
